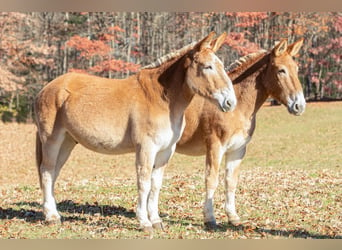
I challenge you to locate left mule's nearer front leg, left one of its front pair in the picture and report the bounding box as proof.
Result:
[136,146,155,232]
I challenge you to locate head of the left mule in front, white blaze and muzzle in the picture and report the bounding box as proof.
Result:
[186,32,237,112]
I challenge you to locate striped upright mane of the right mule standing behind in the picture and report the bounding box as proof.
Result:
[226,50,268,79]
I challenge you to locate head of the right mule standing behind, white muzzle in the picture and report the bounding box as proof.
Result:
[265,39,306,115]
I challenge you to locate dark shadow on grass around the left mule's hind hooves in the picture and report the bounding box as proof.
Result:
[0,200,136,223]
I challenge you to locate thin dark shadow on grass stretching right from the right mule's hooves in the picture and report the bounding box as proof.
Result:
[205,223,342,239]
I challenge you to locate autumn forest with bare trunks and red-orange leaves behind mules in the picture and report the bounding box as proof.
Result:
[0,12,342,122]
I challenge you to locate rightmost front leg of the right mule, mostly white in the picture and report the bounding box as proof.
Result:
[225,147,246,225]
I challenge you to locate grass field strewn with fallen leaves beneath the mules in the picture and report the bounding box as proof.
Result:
[0,102,342,239]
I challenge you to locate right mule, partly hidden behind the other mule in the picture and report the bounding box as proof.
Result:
[176,40,305,229]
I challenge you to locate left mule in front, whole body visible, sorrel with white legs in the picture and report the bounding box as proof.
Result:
[34,33,236,231]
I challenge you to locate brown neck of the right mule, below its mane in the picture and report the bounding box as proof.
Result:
[234,53,269,116]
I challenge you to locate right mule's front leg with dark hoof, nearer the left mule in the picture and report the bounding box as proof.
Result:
[203,140,222,229]
